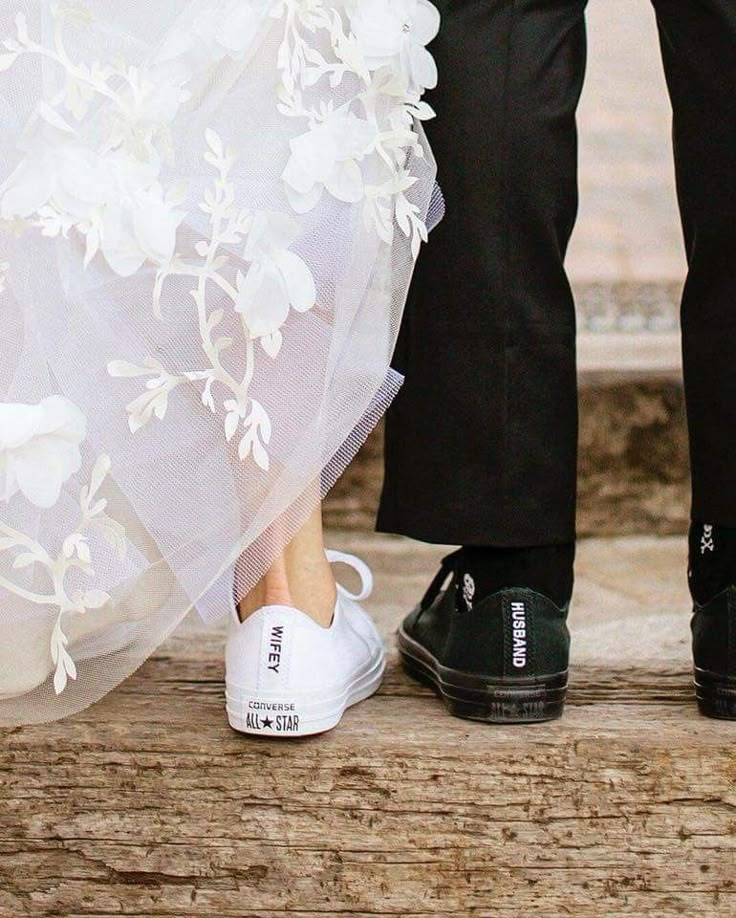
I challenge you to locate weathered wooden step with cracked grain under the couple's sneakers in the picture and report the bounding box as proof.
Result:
[0,538,736,918]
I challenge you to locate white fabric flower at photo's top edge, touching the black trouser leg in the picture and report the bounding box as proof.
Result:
[350,0,440,92]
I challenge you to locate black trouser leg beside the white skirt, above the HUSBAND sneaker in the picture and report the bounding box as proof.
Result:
[379,0,585,547]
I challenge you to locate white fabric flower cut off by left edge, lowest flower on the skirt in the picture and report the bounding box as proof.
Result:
[0,395,87,509]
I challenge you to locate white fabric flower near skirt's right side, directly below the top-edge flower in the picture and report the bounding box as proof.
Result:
[282,109,377,213]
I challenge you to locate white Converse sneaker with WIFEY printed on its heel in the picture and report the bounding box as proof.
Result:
[225,551,386,737]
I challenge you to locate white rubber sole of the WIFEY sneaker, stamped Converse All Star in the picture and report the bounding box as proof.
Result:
[225,654,386,739]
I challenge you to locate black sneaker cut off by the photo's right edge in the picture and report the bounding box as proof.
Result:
[692,586,736,720]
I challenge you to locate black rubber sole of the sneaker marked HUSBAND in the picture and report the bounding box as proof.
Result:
[399,628,567,724]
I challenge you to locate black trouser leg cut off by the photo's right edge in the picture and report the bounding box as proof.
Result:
[654,0,736,527]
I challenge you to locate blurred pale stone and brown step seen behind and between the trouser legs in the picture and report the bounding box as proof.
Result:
[326,0,689,536]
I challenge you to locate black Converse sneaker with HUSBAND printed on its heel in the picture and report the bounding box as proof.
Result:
[399,552,570,723]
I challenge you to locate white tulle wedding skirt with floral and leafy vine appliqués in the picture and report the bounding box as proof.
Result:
[0,0,438,724]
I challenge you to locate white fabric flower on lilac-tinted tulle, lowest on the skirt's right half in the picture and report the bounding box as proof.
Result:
[235,212,317,338]
